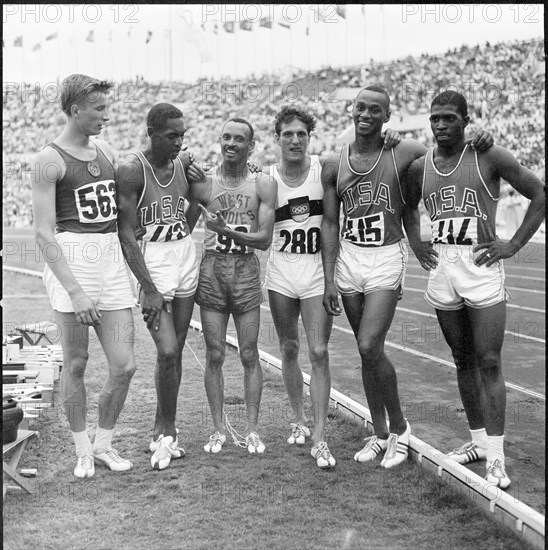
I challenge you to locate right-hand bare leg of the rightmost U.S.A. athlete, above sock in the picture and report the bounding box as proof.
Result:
[468,302,506,436]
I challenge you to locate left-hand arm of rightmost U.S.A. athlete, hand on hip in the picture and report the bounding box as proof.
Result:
[402,156,438,271]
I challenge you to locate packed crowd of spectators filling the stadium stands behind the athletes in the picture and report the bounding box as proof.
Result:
[3,39,545,226]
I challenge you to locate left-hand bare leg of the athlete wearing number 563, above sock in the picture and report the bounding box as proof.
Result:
[54,311,89,433]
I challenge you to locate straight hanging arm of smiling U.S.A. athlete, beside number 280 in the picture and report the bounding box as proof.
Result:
[321,154,342,315]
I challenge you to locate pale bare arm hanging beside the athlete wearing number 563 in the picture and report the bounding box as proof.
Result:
[32,147,101,325]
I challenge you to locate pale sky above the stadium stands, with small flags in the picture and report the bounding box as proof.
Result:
[3,4,544,83]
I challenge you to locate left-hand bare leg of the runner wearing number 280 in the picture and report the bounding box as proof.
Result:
[268,290,308,426]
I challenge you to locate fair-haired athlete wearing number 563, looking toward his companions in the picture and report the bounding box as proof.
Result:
[32,74,135,478]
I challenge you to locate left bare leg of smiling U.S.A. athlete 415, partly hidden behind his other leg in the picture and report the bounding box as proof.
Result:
[342,294,389,439]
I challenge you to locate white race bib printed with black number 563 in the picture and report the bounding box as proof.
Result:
[74,180,118,223]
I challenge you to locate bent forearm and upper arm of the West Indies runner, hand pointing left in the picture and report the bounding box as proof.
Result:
[200,174,278,250]
